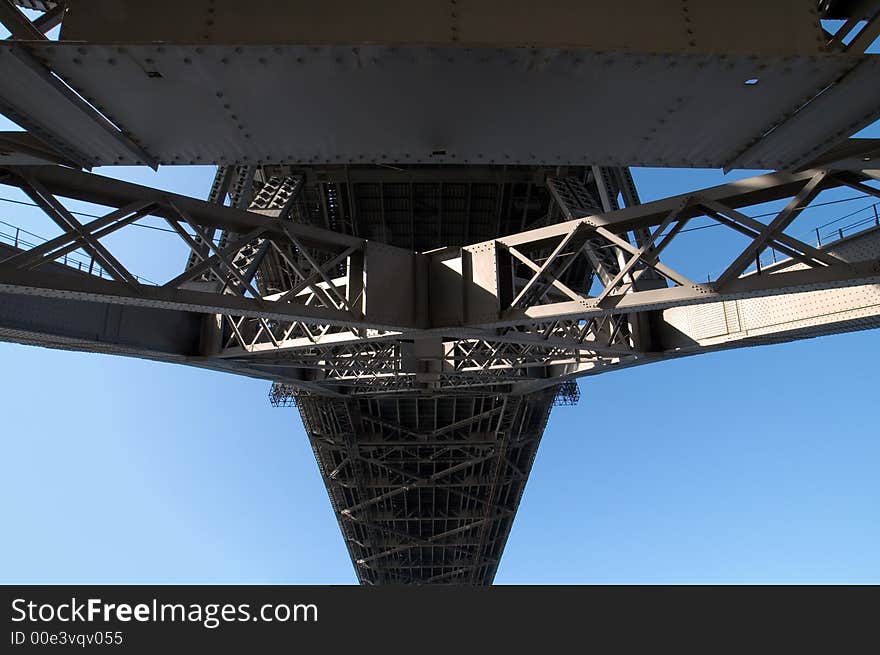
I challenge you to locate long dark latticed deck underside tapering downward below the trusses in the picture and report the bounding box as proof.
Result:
[298,390,554,584]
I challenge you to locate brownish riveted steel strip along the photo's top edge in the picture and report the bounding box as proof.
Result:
[61,0,827,55]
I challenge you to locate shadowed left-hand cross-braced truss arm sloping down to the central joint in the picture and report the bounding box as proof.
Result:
[0,166,428,345]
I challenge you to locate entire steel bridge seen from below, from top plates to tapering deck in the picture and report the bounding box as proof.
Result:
[0,0,880,584]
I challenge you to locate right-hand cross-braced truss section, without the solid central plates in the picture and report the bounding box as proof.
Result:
[488,171,880,325]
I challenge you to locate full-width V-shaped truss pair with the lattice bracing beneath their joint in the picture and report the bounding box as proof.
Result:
[0,161,880,395]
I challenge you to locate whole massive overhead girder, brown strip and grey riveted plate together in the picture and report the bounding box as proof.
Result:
[0,0,878,170]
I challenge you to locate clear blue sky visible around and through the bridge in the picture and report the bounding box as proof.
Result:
[0,21,880,584]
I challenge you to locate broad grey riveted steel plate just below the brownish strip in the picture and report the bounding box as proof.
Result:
[6,44,875,168]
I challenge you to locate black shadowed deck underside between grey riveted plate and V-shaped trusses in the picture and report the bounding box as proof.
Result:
[274,166,556,252]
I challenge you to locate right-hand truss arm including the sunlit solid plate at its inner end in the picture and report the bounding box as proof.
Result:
[435,171,878,338]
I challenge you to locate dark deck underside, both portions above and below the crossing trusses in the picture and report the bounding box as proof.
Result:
[286,166,564,584]
